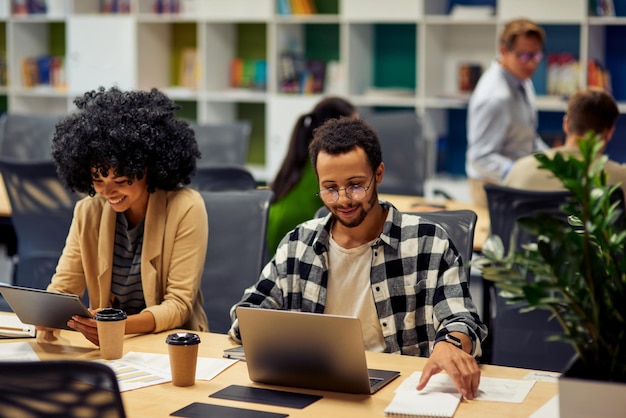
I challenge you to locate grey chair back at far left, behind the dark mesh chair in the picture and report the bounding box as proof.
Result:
[0,113,59,161]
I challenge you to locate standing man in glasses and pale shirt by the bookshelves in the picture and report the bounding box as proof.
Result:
[465,19,548,206]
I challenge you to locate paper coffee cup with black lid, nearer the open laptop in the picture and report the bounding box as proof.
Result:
[165,332,200,386]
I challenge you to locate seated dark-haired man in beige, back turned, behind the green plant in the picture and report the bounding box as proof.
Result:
[504,89,626,196]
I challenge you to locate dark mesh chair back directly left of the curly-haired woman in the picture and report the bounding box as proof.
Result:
[0,159,82,289]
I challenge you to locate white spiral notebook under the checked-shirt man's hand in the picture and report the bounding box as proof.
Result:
[385,372,461,418]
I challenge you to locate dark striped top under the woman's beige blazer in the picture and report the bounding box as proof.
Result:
[111,213,146,315]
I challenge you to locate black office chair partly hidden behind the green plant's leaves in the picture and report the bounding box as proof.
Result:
[483,184,584,372]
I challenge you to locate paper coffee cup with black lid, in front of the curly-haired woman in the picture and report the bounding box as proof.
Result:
[95,308,127,360]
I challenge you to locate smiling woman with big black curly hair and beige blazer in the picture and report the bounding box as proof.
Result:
[48,88,208,345]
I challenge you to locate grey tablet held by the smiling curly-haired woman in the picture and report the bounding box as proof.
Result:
[0,285,91,329]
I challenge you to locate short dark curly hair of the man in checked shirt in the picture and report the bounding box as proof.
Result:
[309,117,383,174]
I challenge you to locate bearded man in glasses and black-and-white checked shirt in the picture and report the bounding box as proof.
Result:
[229,117,487,399]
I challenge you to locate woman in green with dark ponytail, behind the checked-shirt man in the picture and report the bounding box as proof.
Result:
[267,97,356,256]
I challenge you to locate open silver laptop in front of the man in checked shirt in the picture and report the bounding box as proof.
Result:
[237,307,400,394]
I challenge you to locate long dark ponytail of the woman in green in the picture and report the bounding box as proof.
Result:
[270,97,356,200]
